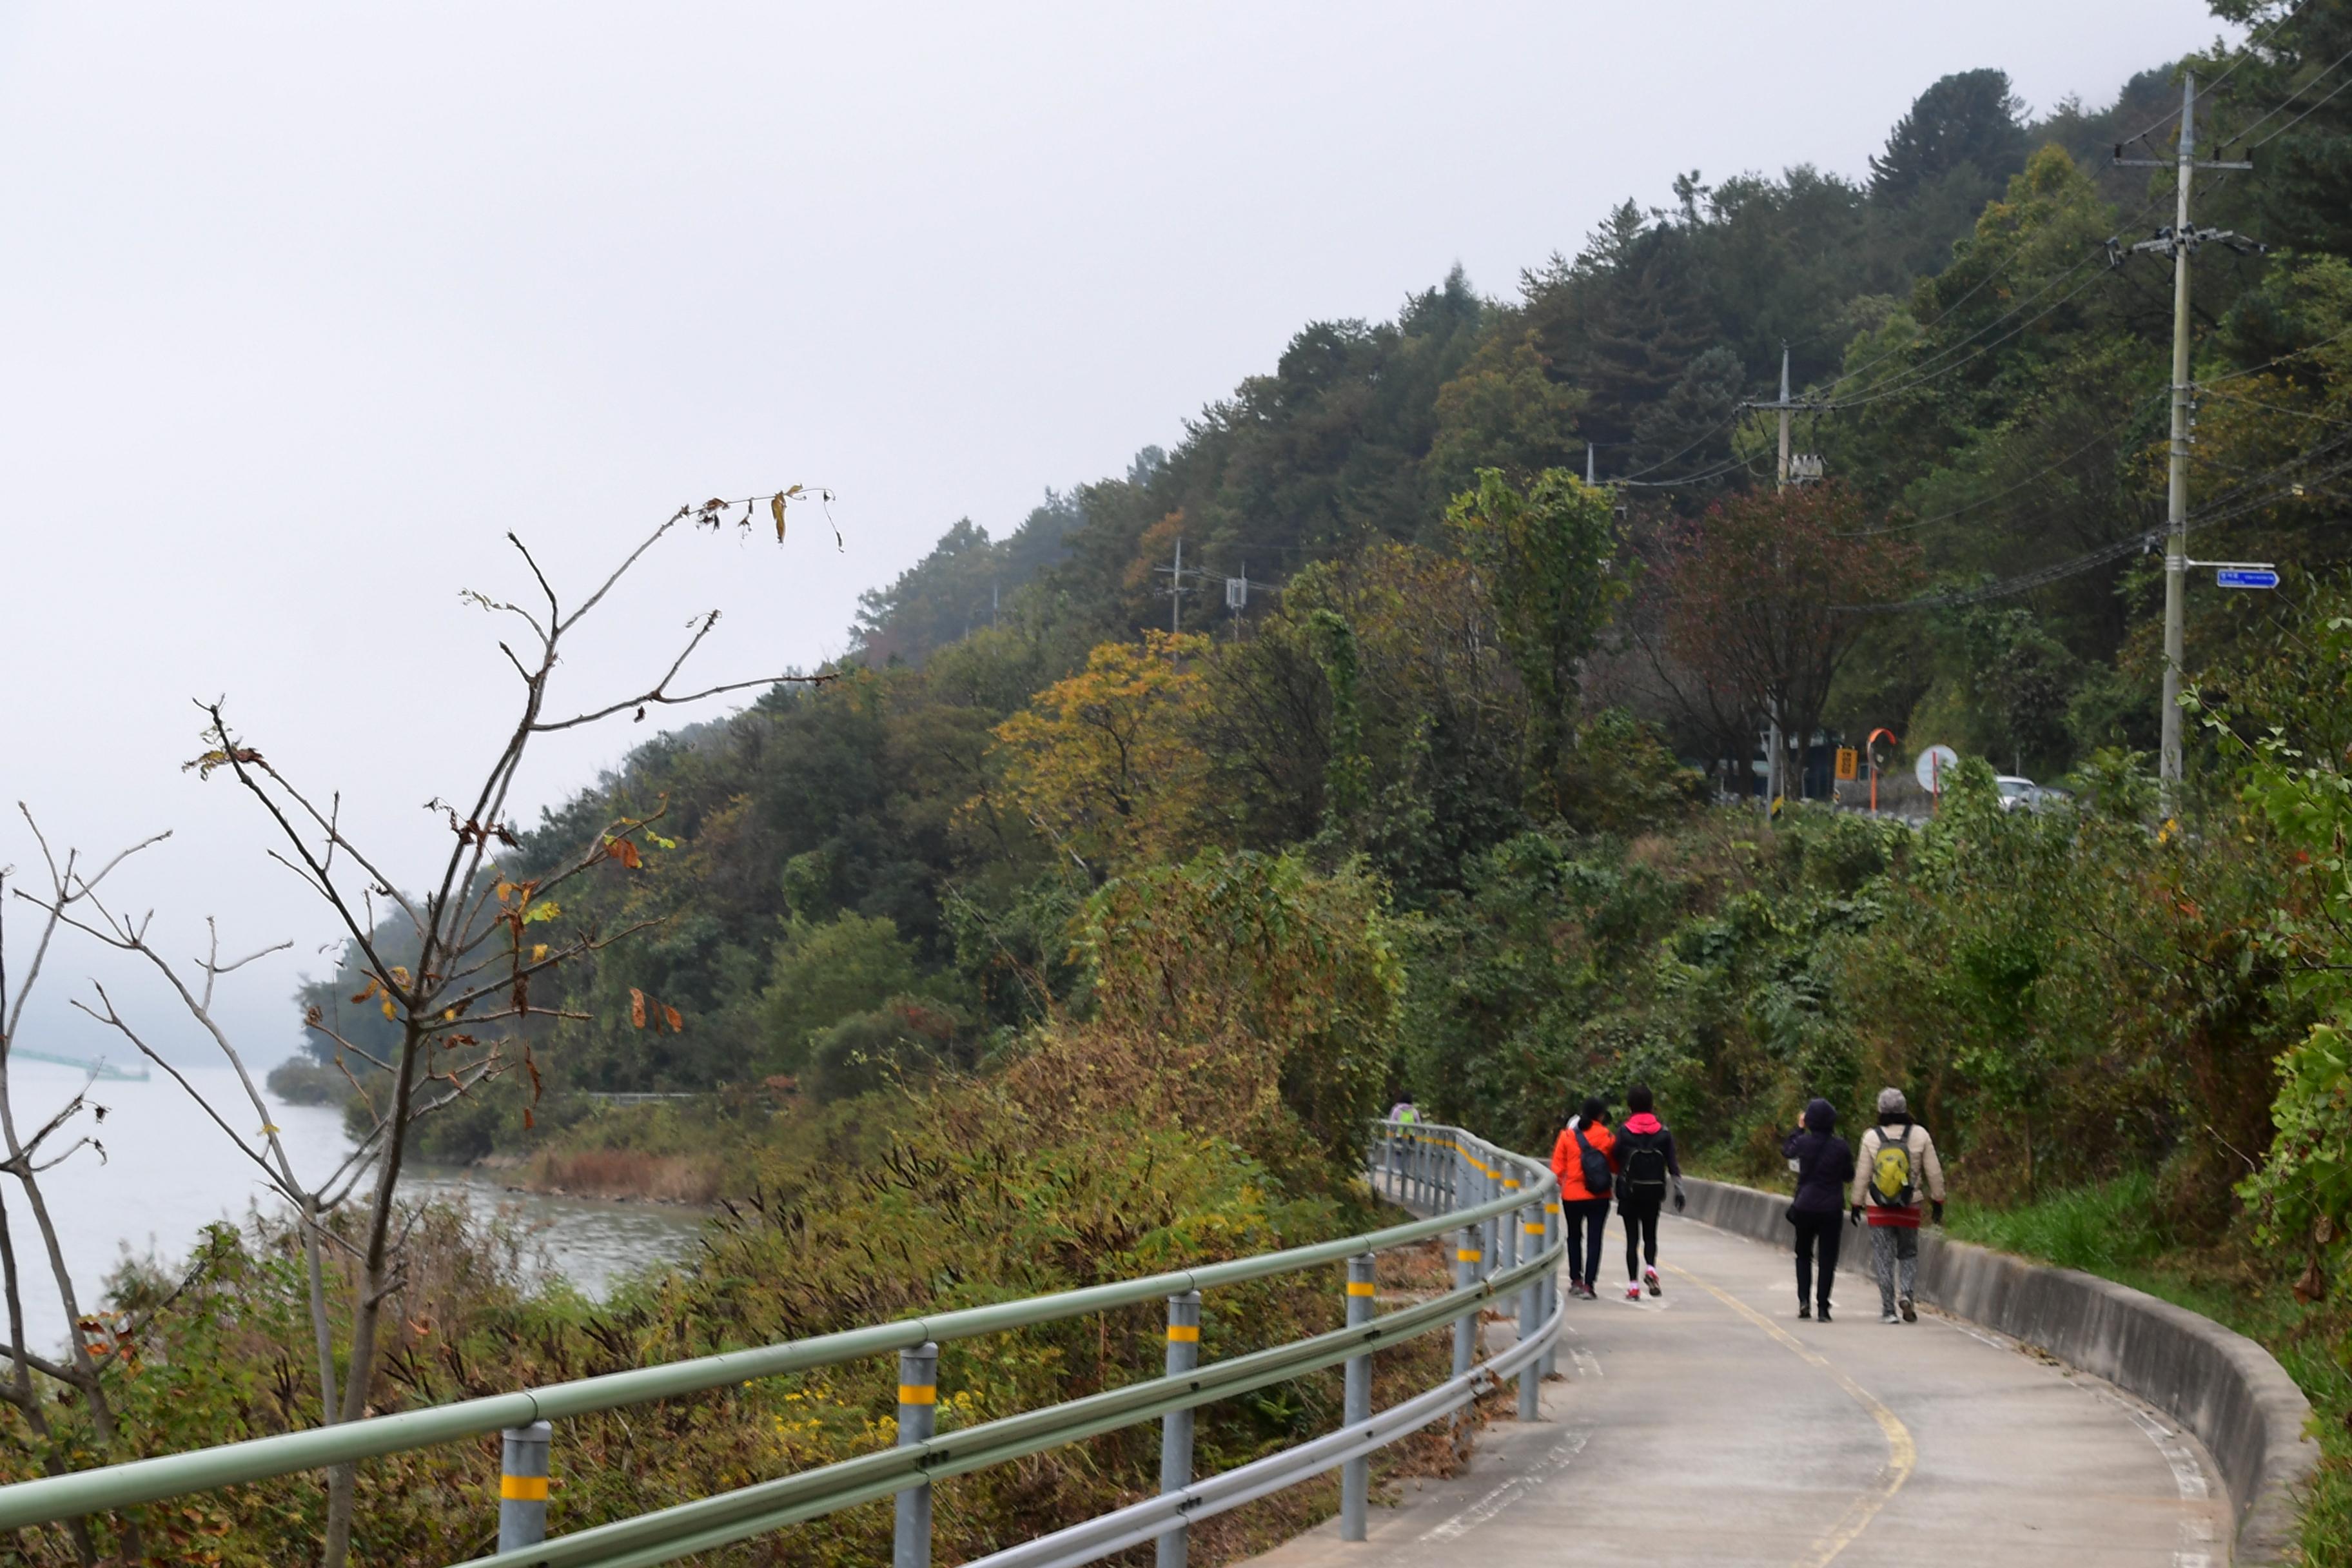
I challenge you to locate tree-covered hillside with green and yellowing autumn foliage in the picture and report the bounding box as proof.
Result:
[92,0,2352,1561]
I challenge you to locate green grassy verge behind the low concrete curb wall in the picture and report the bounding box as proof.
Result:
[1950,1173,2352,1563]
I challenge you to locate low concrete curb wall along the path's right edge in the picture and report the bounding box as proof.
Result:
[1689,1178,2319,1568]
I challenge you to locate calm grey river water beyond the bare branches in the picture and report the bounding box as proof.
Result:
[0,1060,701,1345]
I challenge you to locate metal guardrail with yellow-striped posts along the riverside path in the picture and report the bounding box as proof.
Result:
[0,1121,1564,1568]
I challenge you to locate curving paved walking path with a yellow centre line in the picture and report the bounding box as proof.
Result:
[1253,1215,2230,1568]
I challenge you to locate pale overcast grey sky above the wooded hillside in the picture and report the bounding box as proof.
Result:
[0,0,2218,1060]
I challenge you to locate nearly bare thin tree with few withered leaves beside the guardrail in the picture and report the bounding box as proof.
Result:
[21,484,818,1568]
